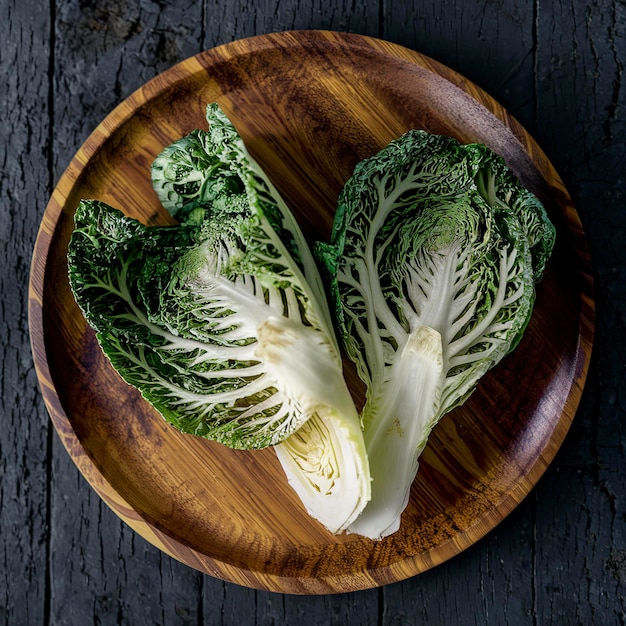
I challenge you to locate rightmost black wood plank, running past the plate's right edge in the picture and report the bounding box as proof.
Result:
[536,1,626,624]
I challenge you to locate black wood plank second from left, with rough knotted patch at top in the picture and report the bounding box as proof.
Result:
[48,1,203,624]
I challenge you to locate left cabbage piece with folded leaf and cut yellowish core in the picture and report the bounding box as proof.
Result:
[68,105,370,532]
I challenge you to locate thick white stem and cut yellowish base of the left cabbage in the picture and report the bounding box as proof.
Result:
[255,317,370,533]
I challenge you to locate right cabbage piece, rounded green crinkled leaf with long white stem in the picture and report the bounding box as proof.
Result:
[317,130,554,538]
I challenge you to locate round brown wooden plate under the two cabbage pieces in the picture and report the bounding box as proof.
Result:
[29,31,594,594]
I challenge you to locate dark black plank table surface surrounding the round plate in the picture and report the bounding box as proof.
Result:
[0,0,626,626]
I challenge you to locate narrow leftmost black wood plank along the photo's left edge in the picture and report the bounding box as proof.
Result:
[0,1,50,624]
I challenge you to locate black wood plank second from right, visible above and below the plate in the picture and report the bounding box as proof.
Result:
[383,0,535,624]
